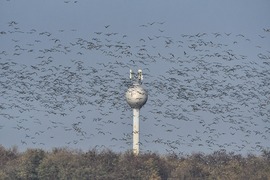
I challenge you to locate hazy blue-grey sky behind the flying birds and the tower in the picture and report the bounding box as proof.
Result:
[0,0,270,154]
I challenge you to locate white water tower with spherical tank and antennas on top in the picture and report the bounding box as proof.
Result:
[126,69,148,155]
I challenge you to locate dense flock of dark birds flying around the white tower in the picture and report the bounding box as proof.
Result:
[0,21,270,153]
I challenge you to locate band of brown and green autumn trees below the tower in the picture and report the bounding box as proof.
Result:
[0,146,270,180]
